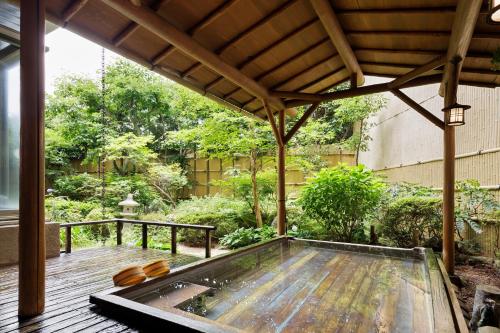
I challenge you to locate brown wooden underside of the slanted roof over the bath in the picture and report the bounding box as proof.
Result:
[47,0,500,118]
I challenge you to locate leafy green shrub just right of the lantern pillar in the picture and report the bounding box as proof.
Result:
[455,179,500,238]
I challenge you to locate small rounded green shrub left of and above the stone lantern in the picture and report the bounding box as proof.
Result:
[54,173,101,201]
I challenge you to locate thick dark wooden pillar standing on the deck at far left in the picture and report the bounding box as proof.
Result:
[18,0,45,317]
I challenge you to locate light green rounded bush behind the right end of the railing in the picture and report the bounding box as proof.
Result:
[172,196,255,244]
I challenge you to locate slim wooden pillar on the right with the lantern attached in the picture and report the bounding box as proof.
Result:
[443,60,460,275]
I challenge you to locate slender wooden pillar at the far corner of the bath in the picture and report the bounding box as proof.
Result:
[278,110,286,236]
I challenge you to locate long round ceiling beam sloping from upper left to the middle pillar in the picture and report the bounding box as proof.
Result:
[103,0,285,110]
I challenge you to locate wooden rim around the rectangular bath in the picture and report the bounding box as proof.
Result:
[90,236,468,333]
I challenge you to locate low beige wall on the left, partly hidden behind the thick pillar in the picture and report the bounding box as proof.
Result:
[0,223,60,266]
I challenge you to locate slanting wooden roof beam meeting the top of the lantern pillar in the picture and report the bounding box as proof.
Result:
[439,0,483,96]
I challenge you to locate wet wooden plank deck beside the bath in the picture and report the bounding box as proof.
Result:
[0,246,199,333]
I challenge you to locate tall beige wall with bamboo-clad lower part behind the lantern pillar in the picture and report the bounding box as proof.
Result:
[360,80,500,193]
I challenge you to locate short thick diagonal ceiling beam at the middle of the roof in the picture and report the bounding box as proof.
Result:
[310,0,365,86]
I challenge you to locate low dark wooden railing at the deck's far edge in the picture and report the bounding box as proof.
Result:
[60,219,216,258]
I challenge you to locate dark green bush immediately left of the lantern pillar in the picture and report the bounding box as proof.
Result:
[381,197,442,247]
